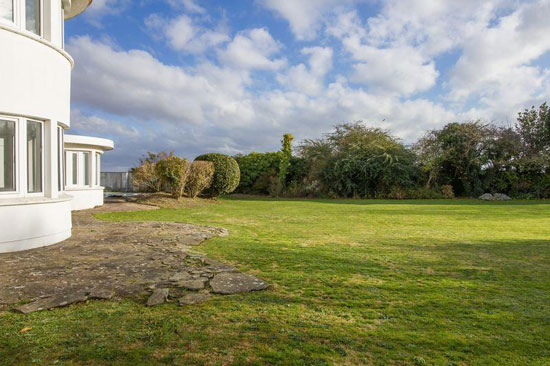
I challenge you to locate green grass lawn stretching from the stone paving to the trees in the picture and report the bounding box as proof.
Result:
[0,199,550,366]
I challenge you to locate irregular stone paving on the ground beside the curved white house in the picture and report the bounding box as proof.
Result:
[0,203,268,313]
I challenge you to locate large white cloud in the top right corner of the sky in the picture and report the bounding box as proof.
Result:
[449,1,550,109]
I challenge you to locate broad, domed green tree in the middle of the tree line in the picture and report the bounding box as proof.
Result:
[300,122,417,197]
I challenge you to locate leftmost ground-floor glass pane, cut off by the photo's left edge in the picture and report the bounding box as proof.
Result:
[0,120,15,192]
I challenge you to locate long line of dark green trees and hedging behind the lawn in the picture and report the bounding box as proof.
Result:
[235,103,550,199]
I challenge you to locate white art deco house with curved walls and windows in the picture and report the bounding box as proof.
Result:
[0,0,112,252]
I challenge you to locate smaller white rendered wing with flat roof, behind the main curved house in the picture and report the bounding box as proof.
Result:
[64,135,114,211]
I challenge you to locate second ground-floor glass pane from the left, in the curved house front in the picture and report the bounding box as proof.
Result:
[27,121,42,193]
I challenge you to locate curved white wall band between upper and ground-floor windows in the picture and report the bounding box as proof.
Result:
[0,24,72,126]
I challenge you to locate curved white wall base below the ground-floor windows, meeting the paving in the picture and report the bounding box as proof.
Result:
[0,196,72,253]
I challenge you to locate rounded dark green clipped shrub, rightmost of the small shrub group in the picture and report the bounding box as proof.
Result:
[195,154,241,197]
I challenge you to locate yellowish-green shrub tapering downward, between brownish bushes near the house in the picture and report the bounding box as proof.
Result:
[155,155,190,198]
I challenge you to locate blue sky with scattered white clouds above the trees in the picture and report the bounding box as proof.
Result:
[65,0,550,171]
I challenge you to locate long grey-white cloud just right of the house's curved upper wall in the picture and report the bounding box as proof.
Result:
[68,37,253,124]
